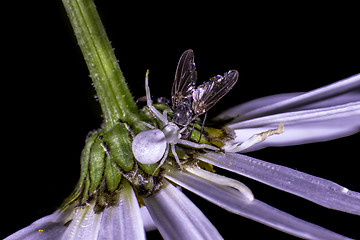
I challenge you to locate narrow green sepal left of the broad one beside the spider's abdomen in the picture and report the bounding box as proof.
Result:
[89,137,105,194]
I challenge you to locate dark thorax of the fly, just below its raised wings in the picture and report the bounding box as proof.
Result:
[172,98,194,126]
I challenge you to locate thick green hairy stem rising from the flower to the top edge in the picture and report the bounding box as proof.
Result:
[62,0,139,129]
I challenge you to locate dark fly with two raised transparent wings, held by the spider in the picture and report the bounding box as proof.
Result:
[171,49,239,127]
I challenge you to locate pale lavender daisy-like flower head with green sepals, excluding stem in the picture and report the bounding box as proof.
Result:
[6,74,360,239]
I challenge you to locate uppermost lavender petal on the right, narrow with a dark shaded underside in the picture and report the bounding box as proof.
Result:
[214,74,360,122]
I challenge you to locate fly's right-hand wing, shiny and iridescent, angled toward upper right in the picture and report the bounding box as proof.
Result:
[192,70,239,118]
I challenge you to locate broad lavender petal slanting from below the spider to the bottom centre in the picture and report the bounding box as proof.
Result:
[144,182,222,240]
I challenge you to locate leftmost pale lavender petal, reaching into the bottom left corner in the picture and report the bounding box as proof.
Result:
[4,211,67,240]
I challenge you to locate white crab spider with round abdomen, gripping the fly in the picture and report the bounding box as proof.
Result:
[132,71,219,171]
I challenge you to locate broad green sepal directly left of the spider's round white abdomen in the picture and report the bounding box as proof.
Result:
[102,123,134,172]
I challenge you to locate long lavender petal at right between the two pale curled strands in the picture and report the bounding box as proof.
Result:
[198,152,360,215]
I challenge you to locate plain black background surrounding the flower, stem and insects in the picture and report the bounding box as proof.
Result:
[0,1,360,239]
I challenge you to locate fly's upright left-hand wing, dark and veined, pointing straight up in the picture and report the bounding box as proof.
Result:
[171,49,197,106]
